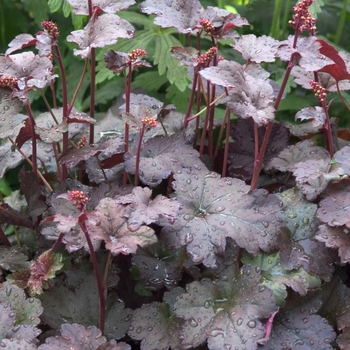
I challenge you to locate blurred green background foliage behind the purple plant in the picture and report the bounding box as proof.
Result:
[0,0,350,123]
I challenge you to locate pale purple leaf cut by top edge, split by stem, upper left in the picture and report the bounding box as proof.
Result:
[67,0,135,16]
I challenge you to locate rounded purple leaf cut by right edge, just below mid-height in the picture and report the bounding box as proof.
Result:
[317,179,350,228]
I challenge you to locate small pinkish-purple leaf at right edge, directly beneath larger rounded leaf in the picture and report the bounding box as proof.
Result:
[315,225,350,264]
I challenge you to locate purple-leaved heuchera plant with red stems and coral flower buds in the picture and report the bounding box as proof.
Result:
[0,0,350,350]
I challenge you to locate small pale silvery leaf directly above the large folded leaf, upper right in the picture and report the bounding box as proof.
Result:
[232,34,280,63]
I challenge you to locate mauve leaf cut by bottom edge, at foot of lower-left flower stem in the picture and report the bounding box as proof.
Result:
[39,323,106,350]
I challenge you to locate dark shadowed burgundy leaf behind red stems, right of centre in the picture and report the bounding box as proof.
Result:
[227,119,289,181]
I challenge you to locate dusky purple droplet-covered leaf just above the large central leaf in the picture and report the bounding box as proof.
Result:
[124,131,203,186]
